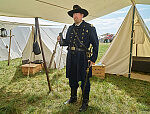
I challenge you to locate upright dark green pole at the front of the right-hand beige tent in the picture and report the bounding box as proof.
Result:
[128,5,135,78]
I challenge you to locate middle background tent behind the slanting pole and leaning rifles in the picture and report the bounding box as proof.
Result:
[22,27,66,68]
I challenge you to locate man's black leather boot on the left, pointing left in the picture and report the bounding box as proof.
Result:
[65,88,77,104]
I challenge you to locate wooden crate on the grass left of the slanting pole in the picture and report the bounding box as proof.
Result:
[21,64,42,75]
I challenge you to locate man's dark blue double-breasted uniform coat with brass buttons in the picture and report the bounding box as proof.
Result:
[60,21,99,81]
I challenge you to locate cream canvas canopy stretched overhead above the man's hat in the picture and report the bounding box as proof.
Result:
[0,0,150,23]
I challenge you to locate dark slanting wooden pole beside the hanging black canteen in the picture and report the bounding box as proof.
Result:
[35,17,51,93]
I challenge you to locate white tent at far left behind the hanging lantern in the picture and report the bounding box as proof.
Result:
[0,27,31,61]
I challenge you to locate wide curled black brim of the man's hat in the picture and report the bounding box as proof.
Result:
[68,9,88,17]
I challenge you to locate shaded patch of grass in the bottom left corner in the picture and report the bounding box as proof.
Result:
[0,88,47,114]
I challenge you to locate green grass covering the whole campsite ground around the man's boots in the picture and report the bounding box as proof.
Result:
[0,44,150,114]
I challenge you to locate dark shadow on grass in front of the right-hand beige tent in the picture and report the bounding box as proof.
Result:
[98,74,150,108]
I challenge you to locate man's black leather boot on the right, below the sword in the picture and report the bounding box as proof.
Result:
[79,94,89,112]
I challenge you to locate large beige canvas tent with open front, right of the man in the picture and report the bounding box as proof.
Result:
[100,7,150,74]
